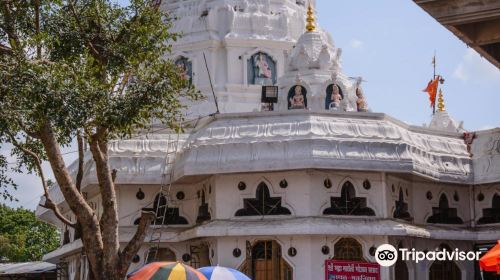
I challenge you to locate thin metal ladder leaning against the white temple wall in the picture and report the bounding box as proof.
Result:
[144,132,180,264]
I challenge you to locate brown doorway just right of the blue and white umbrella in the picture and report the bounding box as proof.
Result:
[240,240,293,280]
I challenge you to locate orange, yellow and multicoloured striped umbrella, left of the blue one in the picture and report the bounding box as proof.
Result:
[128,262,207,280]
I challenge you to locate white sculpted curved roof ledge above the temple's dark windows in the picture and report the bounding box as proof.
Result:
[174,110,472,183]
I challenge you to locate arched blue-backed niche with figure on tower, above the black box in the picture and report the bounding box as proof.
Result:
[247,52,276,86]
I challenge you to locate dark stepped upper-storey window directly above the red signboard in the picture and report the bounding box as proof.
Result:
[323,181,375,216]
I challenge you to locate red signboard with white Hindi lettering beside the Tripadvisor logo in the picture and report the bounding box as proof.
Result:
[325,260,380,280]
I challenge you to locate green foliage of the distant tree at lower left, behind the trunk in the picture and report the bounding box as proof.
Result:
[0,204,59,262]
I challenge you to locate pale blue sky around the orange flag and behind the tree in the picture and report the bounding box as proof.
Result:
[0,0,500,209]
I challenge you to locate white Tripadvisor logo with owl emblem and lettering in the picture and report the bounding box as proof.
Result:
[375,244,481,266]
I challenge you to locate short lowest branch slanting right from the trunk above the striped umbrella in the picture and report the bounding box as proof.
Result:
[120,211,156,274]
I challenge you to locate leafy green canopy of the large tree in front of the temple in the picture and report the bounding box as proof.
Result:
[0,0,200,190]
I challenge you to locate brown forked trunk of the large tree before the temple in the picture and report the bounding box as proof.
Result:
[39,124,155,280]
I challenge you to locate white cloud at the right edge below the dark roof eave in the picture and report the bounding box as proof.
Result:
[453,49,500,83]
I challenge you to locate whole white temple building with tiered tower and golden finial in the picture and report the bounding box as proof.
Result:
[36,0,500,280]
